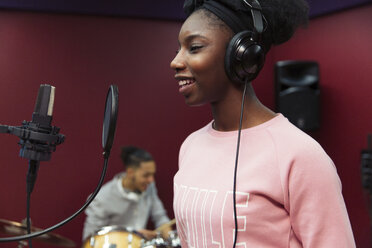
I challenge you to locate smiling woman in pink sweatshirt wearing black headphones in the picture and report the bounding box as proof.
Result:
[171,0,355,248]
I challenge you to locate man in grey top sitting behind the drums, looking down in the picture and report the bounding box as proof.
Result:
[83,146,171,241]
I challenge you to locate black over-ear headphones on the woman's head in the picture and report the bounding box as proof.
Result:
[225,0,265,83]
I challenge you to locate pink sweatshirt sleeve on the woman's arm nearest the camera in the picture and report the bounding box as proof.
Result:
[287,144,356,248]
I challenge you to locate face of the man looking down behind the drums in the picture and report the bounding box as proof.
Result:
[131,161,156,192]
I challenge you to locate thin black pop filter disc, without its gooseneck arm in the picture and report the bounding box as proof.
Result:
[102,85,119,155]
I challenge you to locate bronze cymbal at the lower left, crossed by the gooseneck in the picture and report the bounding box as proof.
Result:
[0,219,76,247]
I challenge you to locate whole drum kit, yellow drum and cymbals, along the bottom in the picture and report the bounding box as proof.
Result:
[0,219,181,248]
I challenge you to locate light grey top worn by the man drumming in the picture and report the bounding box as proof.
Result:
[83,173,169,240]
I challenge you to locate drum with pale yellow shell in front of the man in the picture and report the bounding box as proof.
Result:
[82,226,142,248]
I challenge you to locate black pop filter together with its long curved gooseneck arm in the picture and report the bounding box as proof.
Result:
[0,85,119,243]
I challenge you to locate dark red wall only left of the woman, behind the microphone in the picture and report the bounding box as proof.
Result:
[0,11,198,247]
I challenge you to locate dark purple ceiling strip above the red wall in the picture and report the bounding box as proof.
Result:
[0,0,372,20]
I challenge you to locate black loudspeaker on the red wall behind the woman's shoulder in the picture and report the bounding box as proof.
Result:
[275,60,320,131]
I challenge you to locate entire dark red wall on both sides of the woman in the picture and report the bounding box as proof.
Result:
[0,2,372,248]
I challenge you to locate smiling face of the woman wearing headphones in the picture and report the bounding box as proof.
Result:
[171,11,231,106]
